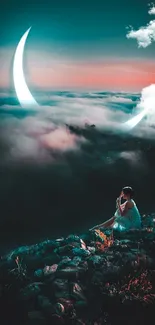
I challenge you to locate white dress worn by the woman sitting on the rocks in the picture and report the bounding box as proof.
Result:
[113,200,141,231]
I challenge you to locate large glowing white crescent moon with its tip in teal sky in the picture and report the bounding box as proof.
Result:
[13,27,39,108]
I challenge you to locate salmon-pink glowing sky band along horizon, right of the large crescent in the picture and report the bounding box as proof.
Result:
[21,61,155,91]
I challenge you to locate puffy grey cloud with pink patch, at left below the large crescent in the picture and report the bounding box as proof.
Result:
[0,115,85,164]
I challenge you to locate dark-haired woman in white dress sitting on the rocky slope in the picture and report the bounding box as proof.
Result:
[90,186,141,231]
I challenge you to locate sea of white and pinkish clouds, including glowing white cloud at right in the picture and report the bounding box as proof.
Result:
[0,89,155,163]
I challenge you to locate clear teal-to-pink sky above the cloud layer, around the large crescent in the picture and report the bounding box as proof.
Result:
[0,0,155,91]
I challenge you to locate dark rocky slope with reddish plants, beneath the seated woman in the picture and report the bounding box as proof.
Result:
[0,215,155,325]
